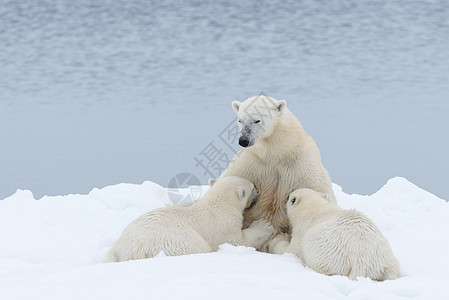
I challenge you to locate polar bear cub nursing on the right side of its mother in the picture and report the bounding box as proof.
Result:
[269,189,400,281]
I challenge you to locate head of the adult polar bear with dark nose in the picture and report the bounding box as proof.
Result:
[232,95,287,148]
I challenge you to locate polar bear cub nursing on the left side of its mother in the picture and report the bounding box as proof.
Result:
[108,176,274,262]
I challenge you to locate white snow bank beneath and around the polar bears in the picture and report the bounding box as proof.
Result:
[0,177,449,299]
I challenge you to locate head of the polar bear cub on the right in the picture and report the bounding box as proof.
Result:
[286,189,330,217]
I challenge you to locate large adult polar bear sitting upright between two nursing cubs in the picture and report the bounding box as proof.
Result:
[211,95,336,251]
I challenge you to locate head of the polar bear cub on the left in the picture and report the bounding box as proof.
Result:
[211,176,259,211]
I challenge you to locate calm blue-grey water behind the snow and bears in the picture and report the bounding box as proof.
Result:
[0,0,449,199]
